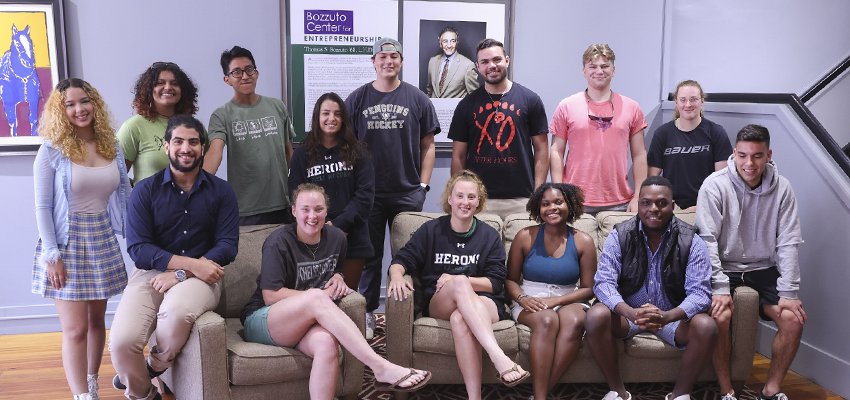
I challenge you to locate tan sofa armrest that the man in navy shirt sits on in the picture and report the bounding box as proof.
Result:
[162,311,230,400]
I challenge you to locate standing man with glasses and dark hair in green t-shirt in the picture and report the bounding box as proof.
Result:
[204,46,295,225]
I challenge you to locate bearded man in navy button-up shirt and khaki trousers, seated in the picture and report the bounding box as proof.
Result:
[109,115,239,399]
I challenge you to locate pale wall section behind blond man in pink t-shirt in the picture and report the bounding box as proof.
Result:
[511,0,664,120]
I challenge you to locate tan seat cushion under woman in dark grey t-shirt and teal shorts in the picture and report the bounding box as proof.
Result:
[225,318,342,385]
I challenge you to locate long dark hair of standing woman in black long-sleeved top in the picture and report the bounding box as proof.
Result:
[301,92,369,167]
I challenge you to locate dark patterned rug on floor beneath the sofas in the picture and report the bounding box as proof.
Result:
[358,314,756,400]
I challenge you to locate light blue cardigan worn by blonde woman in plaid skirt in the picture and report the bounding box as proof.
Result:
[33,140,131,267]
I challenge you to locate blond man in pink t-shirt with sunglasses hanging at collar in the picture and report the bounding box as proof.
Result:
[549,44,647,214]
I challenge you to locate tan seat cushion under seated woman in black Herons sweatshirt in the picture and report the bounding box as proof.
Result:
[413,317,518,356]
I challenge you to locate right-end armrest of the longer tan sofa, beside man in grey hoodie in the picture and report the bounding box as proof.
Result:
[729,286,759,381]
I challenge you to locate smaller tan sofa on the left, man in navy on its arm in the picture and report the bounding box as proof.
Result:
[162,225,366,399]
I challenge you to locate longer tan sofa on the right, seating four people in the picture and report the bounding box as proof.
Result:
[387,212,758,397]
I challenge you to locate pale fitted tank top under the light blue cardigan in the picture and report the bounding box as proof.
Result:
[68,160,121,213]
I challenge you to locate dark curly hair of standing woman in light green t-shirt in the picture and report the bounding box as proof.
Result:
[133,62,198,121]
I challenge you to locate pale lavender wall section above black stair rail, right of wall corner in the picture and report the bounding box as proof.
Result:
[663,0,850,99]
